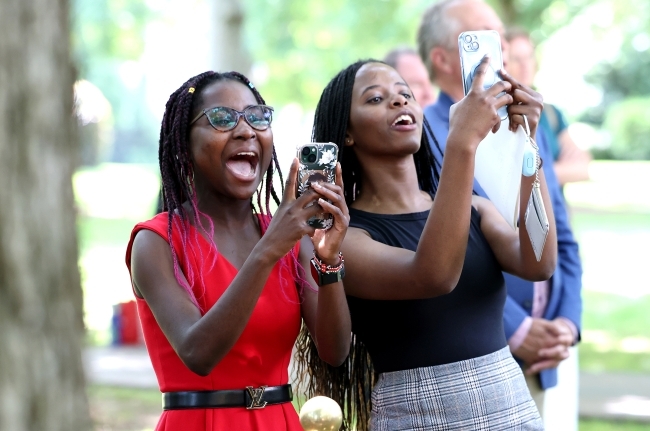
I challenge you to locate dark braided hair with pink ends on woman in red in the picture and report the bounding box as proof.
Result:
[158,71,288,309]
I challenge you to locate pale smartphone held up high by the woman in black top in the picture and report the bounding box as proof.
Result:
[458,30,508,120]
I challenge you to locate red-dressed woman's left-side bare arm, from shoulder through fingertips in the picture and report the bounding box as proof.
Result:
[131,161,344,375]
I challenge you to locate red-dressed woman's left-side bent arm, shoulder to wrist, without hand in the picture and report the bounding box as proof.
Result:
[131,230,276,376]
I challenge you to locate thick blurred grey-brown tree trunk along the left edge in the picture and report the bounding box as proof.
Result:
[0,0,91,431]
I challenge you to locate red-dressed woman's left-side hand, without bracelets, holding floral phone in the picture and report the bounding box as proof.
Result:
[260,158,332,262]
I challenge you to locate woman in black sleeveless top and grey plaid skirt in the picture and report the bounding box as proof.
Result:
[298,59,557,431]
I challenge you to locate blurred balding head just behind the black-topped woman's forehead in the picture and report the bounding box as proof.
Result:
[384,47,436,108]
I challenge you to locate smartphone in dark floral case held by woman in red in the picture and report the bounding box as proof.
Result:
[296,142,339,229]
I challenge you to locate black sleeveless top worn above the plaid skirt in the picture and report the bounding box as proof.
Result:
[347,208,506,372]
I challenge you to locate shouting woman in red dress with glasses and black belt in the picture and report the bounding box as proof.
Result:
[126,72,350,431]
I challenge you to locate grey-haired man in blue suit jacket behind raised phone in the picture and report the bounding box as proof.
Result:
[417,0,582,430]
